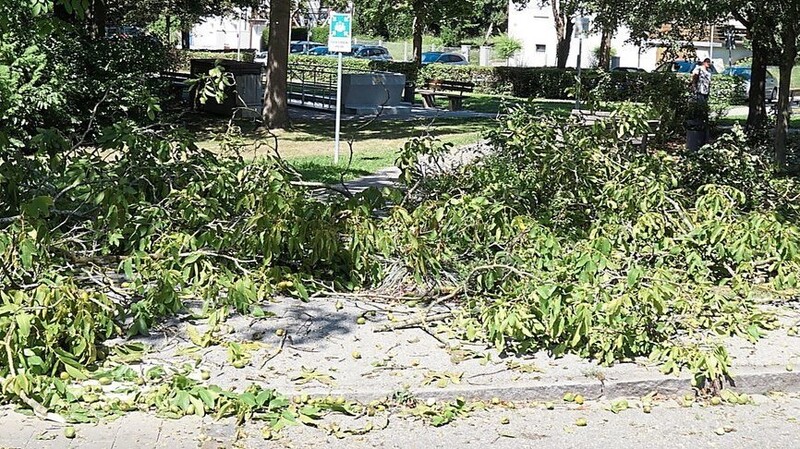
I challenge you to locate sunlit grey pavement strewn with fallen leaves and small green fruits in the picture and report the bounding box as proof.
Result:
[0,296,800,449]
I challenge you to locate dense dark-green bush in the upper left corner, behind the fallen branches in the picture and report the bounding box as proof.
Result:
[0,4,169,156]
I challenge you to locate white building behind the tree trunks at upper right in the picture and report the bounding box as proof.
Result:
[508,0,750,71]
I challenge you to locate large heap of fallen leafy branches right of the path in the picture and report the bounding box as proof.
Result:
[386,105,800,386]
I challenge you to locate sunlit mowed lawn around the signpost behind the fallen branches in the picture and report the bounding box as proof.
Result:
[198,118,495,183]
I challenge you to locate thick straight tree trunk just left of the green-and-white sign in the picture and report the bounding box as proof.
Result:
[263,0,292,128]
